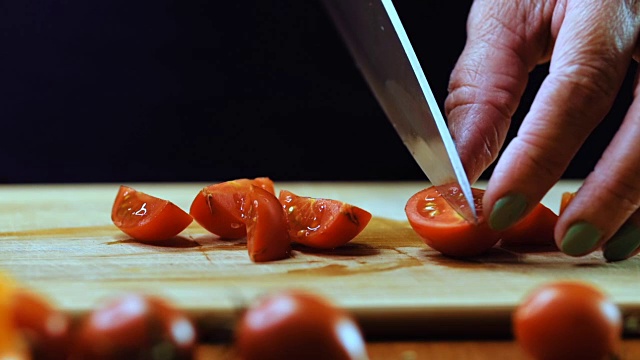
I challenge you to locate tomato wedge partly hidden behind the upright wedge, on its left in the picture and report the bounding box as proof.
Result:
[189,177,275,239]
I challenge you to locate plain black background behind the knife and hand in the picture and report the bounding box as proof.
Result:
[0,0,631,183]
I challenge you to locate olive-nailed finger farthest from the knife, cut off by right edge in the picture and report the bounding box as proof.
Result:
[556,68,640,261]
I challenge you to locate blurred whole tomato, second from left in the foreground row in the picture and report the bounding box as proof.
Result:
[71,293,196,360]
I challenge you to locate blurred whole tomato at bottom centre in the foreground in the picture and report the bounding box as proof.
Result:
[235,290,367,360]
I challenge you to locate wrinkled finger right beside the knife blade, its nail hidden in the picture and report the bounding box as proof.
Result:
[445,0,551,183]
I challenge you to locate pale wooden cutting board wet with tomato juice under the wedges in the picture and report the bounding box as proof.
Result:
[0,181,640,337]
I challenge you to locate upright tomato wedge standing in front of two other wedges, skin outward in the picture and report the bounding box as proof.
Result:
[244,185,291,262]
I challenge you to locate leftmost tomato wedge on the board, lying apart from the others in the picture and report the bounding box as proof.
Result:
[111,185,193,241]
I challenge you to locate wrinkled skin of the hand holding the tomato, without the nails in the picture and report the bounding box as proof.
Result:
[445,0,640,260]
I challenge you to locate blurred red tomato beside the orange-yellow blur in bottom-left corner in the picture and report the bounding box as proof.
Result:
[12,289,71,360]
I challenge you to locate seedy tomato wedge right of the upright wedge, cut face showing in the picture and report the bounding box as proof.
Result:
[279,190,372,249]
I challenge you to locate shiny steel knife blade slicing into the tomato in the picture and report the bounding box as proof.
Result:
[323,0,478,223]
